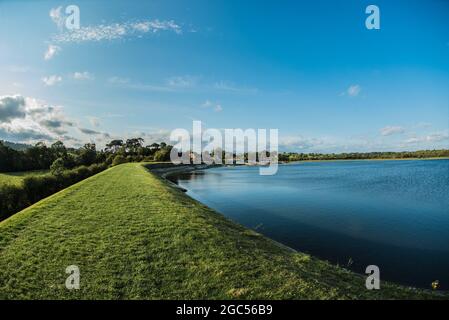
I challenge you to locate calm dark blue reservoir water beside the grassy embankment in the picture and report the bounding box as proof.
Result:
[171,160,449,290]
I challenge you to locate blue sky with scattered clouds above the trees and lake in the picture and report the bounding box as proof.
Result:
[0,0,449,152]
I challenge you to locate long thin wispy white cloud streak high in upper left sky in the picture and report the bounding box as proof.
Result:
[52,19,182,43]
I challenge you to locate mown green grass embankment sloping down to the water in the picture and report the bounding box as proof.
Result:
[0,164,447,299]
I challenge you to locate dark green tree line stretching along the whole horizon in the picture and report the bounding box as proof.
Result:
[0,138,449,174]
